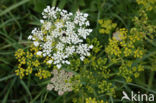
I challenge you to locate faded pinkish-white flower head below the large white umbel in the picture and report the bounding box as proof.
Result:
[47,69,73,95]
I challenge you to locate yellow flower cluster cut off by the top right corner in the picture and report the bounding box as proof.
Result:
[136,0,156,11]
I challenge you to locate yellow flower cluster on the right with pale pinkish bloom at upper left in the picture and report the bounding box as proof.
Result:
[105,28,143,58]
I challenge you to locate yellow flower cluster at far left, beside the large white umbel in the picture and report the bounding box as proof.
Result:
[15,45,51,79]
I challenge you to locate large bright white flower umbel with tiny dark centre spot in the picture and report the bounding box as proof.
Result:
[28,6,93,68]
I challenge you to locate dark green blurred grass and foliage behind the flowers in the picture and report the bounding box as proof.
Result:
[0,0,156,103]
